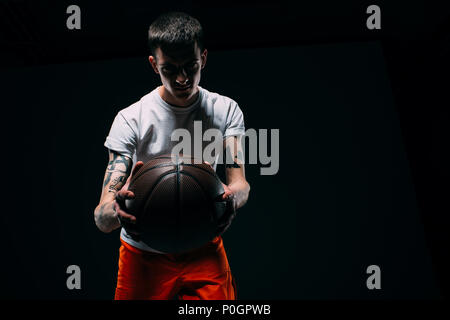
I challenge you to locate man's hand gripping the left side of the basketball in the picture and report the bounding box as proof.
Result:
[113,161,144,236]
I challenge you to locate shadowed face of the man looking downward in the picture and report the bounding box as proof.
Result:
[149,44,207,101]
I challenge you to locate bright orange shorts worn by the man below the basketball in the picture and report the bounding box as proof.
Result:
[114,237,236,300]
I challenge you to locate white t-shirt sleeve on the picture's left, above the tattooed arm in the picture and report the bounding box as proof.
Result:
[104,112,137,159]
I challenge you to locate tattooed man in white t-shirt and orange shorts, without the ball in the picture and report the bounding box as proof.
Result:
[94,12,250,300]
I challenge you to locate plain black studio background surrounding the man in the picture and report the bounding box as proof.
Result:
[0,1,450,299]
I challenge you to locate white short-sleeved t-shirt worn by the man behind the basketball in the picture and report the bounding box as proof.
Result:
[104,86,245,252]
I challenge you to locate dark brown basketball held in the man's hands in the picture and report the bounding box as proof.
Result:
[125,155,226,253]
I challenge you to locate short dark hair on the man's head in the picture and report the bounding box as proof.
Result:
[148,11,204,56]
